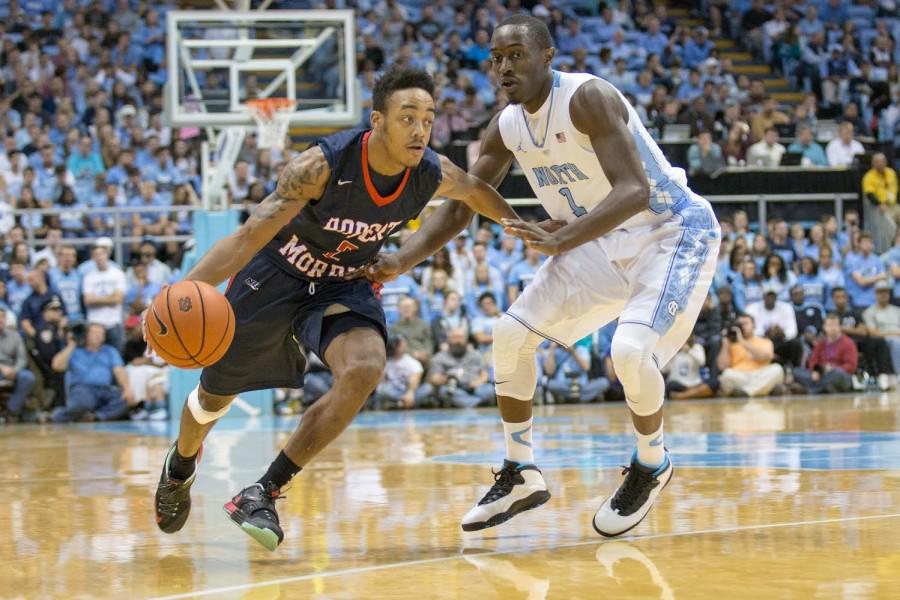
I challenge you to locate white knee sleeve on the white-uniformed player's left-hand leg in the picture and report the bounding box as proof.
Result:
[493,315,541,401]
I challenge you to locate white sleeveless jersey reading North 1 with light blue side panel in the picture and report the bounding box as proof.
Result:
[500,71,704,229]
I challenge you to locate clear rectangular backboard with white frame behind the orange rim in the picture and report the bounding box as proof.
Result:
[165,10,360,128]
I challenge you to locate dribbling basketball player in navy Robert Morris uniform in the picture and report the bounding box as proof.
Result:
[150,68,515,550]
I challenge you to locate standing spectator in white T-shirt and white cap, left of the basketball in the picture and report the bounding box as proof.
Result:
[82,245,128,351]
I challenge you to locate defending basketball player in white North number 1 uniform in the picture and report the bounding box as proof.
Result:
[358,15,720,536]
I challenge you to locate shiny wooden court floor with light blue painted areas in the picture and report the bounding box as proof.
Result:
[0,394,900,600]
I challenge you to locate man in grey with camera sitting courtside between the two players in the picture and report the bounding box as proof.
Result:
[416,327,494,408]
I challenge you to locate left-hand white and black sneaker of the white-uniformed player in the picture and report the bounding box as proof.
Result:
[462,460,550,531]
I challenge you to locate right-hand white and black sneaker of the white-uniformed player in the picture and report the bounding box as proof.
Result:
[593,452,674,537]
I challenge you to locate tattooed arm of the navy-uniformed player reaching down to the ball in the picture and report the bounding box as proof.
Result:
[186,146,331,285]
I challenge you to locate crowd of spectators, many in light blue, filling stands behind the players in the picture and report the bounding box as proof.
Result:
[0,0,900,421]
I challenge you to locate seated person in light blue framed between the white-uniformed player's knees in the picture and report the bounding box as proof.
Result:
[538,337,609,404]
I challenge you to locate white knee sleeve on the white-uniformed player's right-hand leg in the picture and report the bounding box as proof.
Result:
[611,323,665,416]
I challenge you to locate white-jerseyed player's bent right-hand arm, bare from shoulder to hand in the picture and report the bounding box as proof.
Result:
[504,80,650,255]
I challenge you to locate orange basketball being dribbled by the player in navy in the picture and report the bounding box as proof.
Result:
[146,280,235,369]
